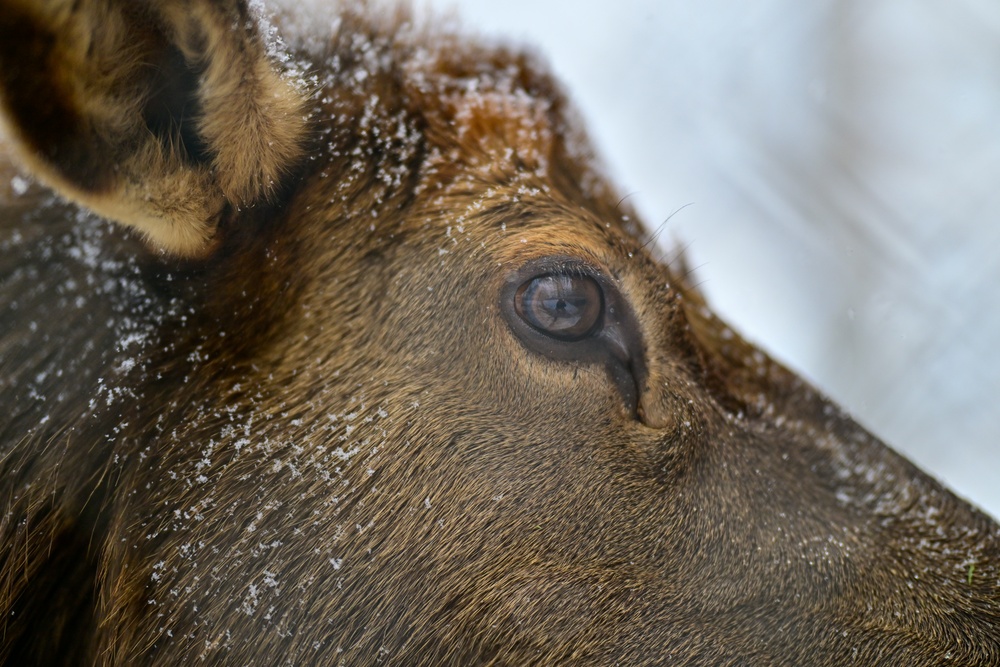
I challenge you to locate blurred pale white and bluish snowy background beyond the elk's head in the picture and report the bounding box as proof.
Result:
[424,0,1000,517]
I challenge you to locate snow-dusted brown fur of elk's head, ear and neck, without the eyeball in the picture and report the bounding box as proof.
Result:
[0,0,1000,665]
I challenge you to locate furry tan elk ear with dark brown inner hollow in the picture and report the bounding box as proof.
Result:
[0,0,306,256]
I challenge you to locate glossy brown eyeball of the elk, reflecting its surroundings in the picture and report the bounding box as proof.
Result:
[514,274,604,341]
